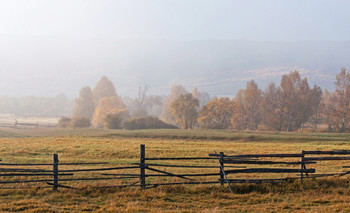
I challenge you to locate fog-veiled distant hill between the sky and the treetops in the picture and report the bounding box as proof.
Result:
[0,36,350,97]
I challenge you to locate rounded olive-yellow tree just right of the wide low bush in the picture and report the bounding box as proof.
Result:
[170,93,199,129]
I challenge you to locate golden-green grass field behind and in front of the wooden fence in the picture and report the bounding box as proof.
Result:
[0,128,350,212]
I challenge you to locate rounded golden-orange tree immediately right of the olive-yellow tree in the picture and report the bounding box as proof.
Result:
[197,98,235,129]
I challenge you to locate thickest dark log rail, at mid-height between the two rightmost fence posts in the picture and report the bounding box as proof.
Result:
[226,168,316,174]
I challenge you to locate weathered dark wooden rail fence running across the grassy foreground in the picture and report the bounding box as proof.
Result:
[0,145,350,191]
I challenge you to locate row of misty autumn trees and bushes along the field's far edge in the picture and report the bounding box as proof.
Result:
[66,69,350,132]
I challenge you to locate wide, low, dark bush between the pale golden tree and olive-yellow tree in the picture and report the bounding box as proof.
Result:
[124,117,178,130]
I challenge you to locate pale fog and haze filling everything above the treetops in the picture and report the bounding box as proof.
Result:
[0,0,350,99]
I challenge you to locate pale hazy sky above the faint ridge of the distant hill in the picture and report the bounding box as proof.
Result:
[0,0,350,41]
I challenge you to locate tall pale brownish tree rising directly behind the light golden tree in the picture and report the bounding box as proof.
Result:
[92,76,117,106]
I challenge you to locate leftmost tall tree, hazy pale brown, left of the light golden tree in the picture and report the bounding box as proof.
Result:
[73,87,95,120]
